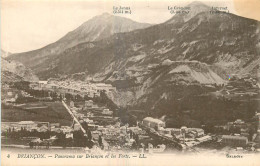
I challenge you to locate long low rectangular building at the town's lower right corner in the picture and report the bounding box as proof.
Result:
[222,135,248,146]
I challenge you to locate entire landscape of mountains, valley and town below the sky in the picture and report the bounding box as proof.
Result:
[1,2,260,152]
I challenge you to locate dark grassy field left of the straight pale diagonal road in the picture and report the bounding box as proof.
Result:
[1,102,72,125]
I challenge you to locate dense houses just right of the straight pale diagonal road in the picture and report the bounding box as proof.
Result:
[69,100,146,150]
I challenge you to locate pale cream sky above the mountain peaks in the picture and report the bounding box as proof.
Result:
[1,0,260,53]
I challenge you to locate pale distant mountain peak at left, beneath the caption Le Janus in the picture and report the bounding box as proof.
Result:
[9,13,150,73]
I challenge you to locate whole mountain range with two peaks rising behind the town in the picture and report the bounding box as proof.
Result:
[8,2,260,126]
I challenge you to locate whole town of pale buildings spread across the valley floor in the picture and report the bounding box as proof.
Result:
[1,78,260,153]
